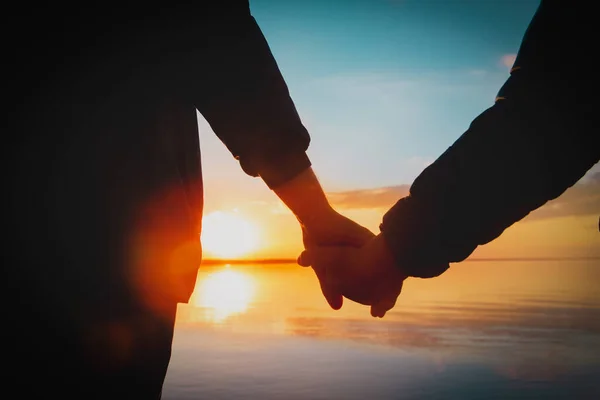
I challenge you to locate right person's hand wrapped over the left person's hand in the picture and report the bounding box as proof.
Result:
[298,236,406,318]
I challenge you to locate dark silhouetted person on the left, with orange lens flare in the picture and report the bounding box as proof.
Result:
[5,1,373,399]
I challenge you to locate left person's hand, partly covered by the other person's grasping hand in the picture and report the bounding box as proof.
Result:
[302,210,375,310]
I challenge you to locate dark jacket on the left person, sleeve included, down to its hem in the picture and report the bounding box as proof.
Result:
[7,1,310,318]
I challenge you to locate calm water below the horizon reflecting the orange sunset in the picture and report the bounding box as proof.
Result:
[163,260,600,400]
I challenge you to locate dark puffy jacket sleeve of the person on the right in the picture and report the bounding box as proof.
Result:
[380,1,600,278]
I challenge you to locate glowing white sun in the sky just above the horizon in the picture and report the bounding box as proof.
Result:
[201,211,260,259]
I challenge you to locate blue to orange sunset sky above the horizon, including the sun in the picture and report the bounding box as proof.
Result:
[198,0,600,258]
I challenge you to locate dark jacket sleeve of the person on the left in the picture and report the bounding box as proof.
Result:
[194,1,311,188]
